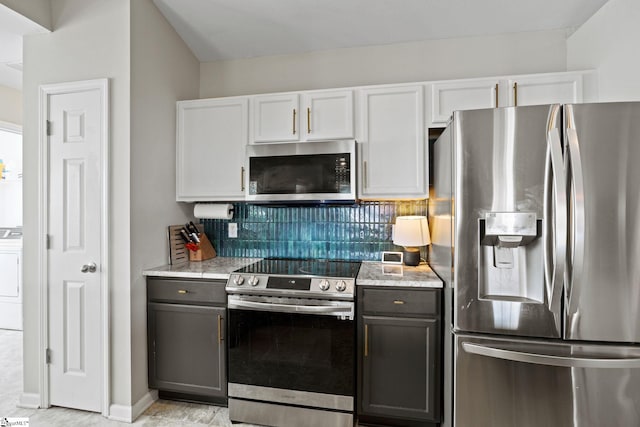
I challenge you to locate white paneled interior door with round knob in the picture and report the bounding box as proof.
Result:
[45,81,107,412]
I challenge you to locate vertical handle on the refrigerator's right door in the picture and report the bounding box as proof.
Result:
[565,105,586,316]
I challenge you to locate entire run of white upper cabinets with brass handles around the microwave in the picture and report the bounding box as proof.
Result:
[176,71,598,202]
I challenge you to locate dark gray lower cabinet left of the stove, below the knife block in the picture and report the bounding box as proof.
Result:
[147,278,227,404]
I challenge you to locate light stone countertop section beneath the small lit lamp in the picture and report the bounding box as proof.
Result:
[356,261,443,288]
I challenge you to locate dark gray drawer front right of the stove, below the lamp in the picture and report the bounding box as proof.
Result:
[358,288,440,316]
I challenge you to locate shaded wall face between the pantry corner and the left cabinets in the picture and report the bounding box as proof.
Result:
[131,0,200,408]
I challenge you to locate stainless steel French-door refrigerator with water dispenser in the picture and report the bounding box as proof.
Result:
[429,103,640,427]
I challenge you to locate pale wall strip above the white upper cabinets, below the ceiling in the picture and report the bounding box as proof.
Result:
[200,31,566,98]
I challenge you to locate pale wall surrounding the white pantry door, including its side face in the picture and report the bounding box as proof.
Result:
[24,0,200,416]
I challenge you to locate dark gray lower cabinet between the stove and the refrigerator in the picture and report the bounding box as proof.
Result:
[357,287,442,426]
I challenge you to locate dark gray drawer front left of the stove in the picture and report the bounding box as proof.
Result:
[147,278,227,304]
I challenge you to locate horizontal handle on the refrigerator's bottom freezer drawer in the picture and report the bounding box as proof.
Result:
[462,342,640,369]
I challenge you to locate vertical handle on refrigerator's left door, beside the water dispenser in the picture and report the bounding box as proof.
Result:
[542,104,567,314]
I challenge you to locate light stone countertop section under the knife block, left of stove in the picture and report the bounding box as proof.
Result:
[142,257,261,280]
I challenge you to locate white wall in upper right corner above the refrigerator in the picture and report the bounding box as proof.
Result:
[567,0,640,101]
